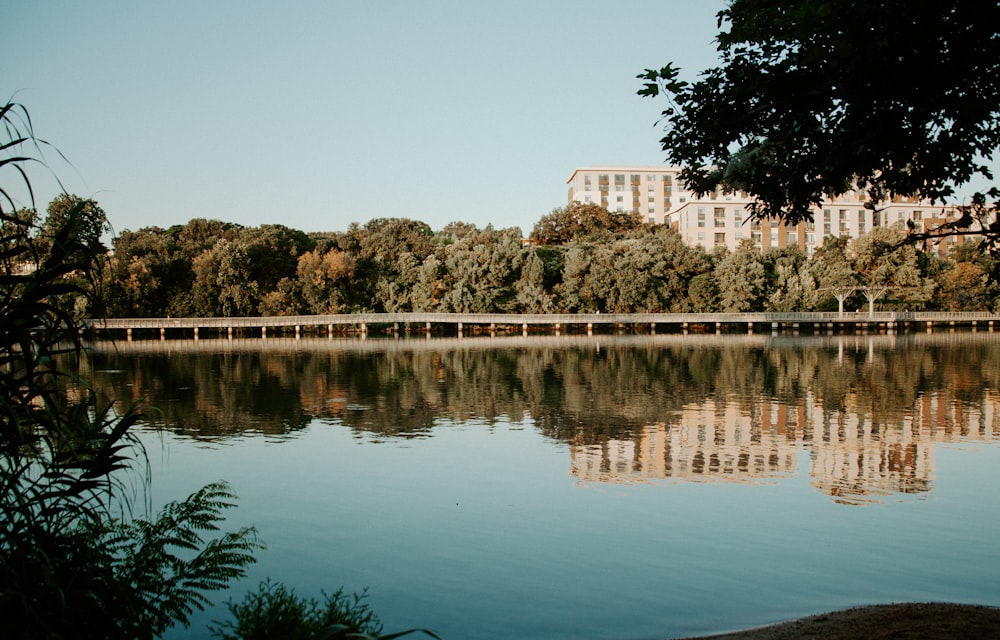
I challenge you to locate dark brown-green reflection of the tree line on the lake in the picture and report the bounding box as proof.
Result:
[84,336,1000,444]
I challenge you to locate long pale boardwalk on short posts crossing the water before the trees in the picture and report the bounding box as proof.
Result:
[86,311,1000,340]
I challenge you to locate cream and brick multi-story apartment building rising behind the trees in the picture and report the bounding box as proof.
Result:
[566,166,959,255]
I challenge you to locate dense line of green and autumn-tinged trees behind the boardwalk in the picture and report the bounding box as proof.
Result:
[21,196,984,317]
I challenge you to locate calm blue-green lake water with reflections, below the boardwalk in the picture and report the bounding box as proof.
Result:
[85,333,1000,640]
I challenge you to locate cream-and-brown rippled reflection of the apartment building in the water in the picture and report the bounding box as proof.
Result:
[570,391,1000,503]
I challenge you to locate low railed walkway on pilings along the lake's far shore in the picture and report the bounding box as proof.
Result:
[86,311,1000,339]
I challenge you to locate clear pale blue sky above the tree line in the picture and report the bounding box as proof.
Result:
[0,0,725,234]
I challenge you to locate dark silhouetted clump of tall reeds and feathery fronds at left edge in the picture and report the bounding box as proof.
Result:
[0,97,260,640]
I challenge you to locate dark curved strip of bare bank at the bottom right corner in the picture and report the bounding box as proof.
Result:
[676,602,1000,640]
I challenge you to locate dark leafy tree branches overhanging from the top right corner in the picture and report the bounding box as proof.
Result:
[639,0,1000,248]
